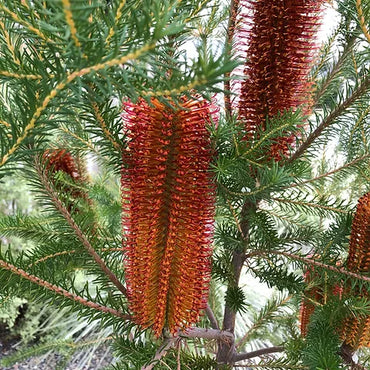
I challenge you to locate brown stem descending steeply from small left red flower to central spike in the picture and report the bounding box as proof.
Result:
[35,162,127,296]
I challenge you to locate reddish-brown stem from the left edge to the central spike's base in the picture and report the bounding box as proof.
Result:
[0,260,130,320]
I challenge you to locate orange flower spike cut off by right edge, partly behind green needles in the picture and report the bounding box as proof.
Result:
[342,192,370,349]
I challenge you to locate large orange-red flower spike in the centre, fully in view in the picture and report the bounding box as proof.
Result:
[122,98,215,336]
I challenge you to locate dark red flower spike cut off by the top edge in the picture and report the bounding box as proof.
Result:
[236,0,323,161]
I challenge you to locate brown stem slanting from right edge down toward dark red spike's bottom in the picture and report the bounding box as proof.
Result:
[287,76,370,163]
